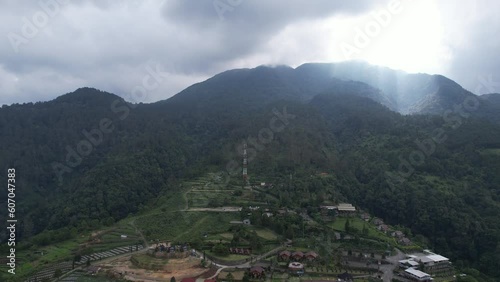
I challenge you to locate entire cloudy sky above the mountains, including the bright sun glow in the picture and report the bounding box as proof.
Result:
[0,0,500,105]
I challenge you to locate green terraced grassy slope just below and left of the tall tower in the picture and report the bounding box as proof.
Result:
[134,174,284,242]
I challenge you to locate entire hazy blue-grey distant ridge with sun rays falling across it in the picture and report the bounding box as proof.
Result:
[165,62,500,121]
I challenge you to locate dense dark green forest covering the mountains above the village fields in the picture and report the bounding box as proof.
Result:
[0,65,500,277]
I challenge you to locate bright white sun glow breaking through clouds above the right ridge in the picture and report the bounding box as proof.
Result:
[329,0,450,73]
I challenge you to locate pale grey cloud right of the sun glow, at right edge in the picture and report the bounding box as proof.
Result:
[438,0,500,94]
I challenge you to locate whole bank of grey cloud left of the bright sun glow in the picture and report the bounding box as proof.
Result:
[0,0,373,104]
